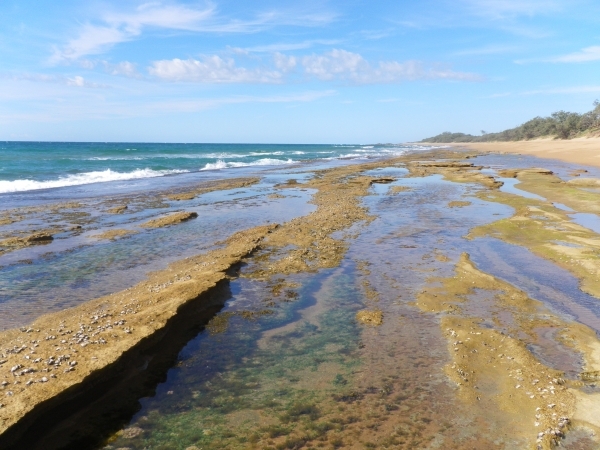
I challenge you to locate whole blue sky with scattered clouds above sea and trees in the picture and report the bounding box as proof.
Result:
[0,0,600,144]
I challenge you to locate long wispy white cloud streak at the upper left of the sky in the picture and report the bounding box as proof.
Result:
[50,2,335,64]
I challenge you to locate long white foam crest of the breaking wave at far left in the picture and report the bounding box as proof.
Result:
[0,169,189,193]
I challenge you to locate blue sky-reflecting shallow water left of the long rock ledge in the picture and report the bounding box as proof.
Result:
[0,185,314,329]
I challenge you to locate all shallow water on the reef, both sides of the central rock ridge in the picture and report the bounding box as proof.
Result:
[0,149,600,450]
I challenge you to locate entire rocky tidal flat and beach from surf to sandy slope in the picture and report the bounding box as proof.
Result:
[0,146,600,450]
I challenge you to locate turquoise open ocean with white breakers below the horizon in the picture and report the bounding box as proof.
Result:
[0,142,430,194]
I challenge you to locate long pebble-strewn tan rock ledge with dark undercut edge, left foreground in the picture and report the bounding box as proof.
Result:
[0,225,277,449]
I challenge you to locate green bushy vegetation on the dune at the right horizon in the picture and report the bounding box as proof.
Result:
[421,100,600,143]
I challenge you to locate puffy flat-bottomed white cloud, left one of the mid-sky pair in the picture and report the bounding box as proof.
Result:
[148,55,282,83]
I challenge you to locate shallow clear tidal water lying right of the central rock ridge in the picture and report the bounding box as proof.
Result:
[109,166,600,449]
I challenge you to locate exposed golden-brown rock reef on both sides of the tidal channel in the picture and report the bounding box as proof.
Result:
[0,148,600,449]
